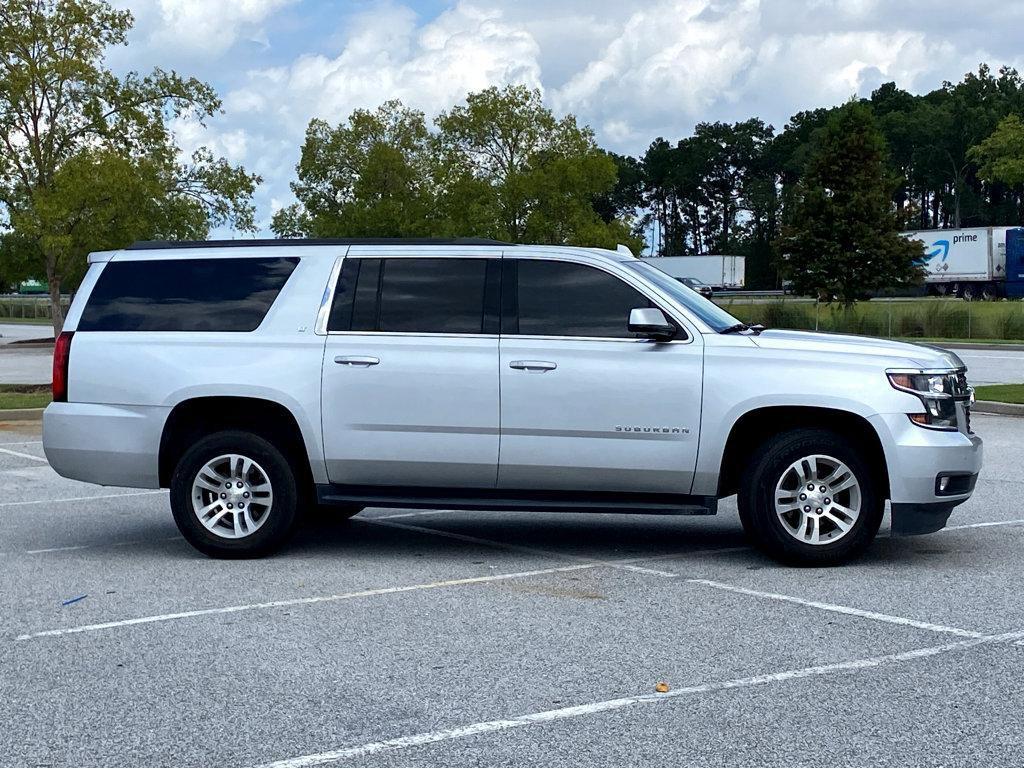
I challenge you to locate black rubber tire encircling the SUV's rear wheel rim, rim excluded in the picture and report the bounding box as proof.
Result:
[171,430,298,558]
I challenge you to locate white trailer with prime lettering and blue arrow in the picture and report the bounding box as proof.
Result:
[902,227,1010,300]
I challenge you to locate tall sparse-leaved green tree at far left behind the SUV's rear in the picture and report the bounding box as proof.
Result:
[0,0,259,332]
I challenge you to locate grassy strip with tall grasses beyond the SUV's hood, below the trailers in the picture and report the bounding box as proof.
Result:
[718,298,1024,341]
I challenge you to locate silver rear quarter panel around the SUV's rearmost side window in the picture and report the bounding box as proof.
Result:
[60,249,334,482]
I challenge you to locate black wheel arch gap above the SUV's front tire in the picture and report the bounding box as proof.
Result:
[718,405,889,499]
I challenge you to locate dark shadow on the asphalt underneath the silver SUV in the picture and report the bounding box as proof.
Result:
[37,510,973,570]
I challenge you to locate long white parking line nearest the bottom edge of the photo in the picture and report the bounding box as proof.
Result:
[267,631,1024,767]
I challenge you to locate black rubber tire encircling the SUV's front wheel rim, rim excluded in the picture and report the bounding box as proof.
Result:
[737,429,885,566]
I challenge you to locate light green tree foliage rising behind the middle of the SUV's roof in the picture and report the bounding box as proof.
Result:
[272,86,642,248]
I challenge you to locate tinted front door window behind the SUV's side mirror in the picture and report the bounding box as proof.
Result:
[509,259,652,339]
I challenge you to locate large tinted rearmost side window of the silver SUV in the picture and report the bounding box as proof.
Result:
[78,257,299,331]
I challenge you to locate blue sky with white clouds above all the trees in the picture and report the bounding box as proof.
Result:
[110,0,1024,234]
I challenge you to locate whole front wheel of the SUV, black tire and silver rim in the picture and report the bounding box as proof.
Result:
[738,429,885,566]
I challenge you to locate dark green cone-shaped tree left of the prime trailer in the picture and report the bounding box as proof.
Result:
[779,102,924,306]
